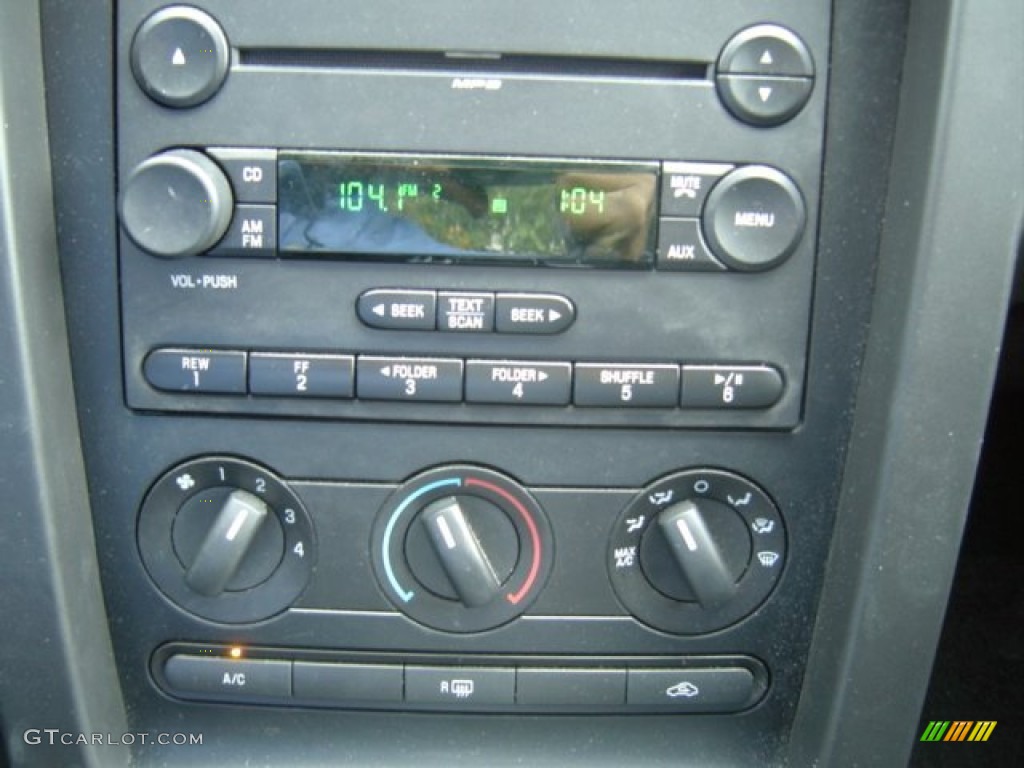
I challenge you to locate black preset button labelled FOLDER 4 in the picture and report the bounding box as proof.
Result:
[466,360,572,406]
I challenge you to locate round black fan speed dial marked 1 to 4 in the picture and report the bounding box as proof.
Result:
[138,457,314,623]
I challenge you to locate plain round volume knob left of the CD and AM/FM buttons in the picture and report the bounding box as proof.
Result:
[119,150,233,258]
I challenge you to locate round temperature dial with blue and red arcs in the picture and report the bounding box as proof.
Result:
[372,466,552,632]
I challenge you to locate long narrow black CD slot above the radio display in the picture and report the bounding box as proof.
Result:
[239,48,711,81]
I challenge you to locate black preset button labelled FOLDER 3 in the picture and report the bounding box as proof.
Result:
[356,356,463,402]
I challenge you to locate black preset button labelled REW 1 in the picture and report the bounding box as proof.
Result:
[142,348,246,394]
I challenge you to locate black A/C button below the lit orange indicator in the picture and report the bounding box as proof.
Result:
[164,653,292,699]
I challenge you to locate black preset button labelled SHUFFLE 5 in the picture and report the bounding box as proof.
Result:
[572,362,679,408]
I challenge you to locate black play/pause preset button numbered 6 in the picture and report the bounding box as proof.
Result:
[681,366,784,409]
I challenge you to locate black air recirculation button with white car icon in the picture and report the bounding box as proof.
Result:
[626,667,754,712]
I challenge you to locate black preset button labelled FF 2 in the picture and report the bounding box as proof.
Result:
[249,352,355,397]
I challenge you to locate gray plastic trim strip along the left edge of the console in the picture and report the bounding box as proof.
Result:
[0,1,129,767]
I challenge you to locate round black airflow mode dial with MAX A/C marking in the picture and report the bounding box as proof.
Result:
[608,469,785,635]
